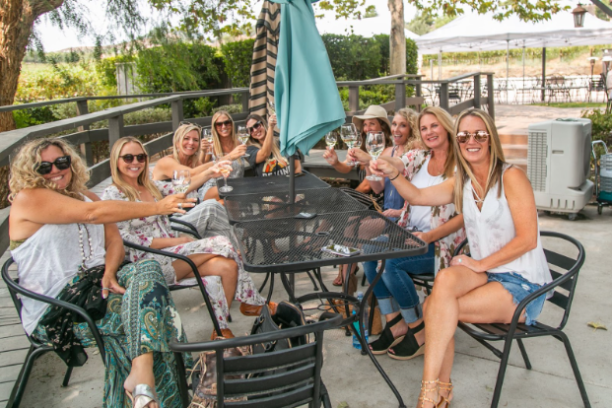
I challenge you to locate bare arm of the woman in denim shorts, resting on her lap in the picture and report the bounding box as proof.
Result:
[451,168,538,272]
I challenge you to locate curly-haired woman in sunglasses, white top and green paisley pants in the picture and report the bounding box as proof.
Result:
[9,138,194,408]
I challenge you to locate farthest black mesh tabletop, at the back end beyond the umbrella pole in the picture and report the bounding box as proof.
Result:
[217,171,329,197]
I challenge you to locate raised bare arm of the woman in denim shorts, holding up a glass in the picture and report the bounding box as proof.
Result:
[370,157,455,206]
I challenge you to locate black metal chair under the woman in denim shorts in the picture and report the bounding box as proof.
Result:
[455,231,591,408]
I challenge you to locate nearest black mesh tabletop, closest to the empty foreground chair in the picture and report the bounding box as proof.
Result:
[233,211,427,272]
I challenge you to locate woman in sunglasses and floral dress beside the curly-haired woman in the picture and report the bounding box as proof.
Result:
[102,137,272,338]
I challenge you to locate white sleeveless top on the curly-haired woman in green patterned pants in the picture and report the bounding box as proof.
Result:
[11,197,106,334]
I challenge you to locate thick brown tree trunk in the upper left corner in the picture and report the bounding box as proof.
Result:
[0,0,64,132]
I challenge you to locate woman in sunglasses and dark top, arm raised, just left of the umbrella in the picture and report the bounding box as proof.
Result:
[246,113,302,177]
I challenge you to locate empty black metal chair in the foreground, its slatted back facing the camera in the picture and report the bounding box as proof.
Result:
[170,315,342,408]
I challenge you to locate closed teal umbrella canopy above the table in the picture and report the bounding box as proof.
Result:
[271,0,346,156]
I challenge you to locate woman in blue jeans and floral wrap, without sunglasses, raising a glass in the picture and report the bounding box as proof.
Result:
[357,107,465,360]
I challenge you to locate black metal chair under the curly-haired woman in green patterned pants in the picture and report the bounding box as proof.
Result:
[2,258,106,408]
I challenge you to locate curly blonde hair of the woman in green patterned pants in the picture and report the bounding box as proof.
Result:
[8,138,89,202]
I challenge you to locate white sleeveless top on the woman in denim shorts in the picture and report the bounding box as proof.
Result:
[463,164,552,285]
